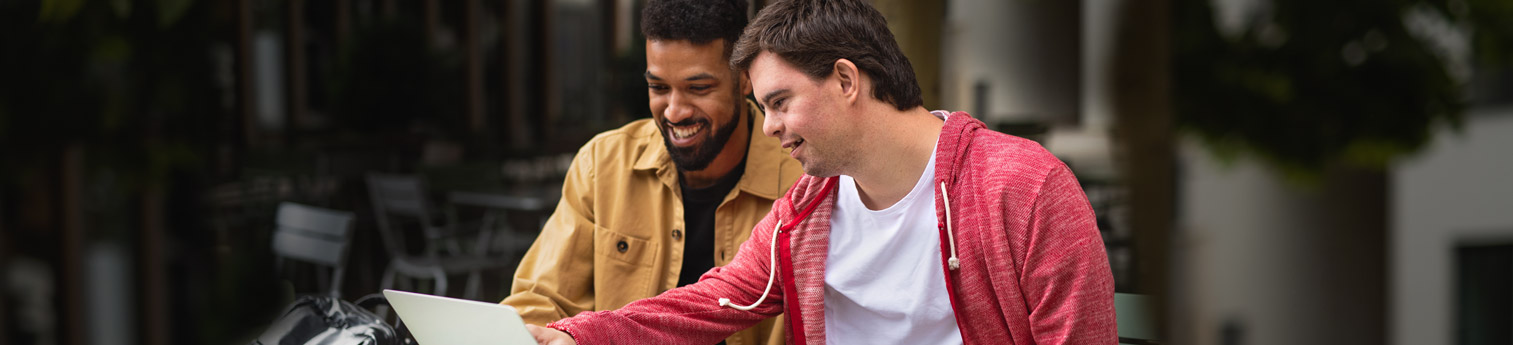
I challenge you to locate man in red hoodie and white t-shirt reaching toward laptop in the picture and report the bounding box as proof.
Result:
[531,0,1118,345]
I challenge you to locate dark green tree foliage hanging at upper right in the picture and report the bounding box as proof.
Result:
[1173,0,1513,176]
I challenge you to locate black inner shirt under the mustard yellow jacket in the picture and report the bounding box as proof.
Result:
[678,157,746,286]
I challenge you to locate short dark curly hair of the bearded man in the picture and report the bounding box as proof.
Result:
[642,0,746,56]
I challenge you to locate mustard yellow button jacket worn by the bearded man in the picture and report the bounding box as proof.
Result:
[502,103,803,345]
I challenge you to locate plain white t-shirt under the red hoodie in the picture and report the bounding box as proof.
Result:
[825,153,962,343]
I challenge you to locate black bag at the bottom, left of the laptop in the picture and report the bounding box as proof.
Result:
[251,294,415,345]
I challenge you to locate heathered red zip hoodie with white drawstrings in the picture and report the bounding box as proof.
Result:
[548,112,1118,345]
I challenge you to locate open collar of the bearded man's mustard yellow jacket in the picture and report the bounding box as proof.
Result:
[631,100,787,200]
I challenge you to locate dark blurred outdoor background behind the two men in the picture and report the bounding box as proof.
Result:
[0,0,1513,345]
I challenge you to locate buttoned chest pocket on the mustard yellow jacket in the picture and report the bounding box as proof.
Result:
[593,227,660,310]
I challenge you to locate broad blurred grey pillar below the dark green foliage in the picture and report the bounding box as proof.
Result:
[1168,138,1381,343]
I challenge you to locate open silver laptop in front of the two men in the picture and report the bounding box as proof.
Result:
[383,289,536,345]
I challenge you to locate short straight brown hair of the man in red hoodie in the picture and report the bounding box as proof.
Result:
[731,0,924,110]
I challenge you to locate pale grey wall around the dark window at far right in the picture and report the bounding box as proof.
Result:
[1387,107,1513,345]
